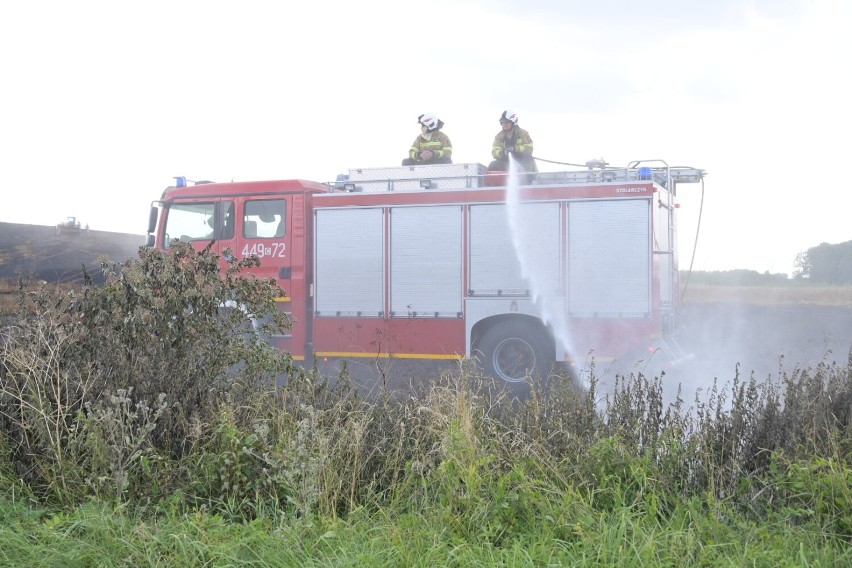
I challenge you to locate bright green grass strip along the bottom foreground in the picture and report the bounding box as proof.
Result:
[0,490,852,567]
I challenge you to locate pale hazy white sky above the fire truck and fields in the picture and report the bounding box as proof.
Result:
[0,0,852,273]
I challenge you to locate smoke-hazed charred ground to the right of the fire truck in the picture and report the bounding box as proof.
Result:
[600,287,852,402]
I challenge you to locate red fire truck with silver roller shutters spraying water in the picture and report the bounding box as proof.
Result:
[148,160,705,383]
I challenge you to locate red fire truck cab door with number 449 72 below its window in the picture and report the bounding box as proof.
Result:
[234,200,305,359]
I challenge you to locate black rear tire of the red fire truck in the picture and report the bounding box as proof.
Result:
[478,321,555,388]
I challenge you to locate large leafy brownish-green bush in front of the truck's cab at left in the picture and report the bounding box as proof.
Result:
[0,244,290,504]
